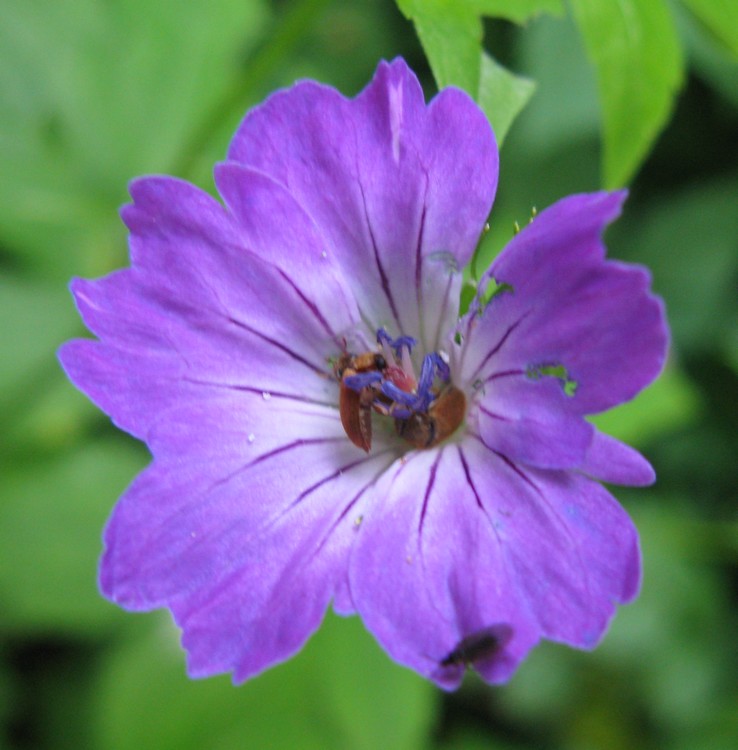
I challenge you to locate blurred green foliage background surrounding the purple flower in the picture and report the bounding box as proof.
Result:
[0,0,738,750]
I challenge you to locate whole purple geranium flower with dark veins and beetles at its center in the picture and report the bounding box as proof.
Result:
[61,59,667,689]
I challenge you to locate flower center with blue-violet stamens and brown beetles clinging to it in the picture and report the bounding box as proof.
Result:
[334,328,466,452]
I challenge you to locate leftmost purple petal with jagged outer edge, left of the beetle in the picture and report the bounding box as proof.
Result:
[60,178,353,438]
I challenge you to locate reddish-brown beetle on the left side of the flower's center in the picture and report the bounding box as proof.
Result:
[333,352,387,453]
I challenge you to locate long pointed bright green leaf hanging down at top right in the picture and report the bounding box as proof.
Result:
[571,0,683,188]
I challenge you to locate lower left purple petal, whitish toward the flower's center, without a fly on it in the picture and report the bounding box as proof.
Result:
[100,426,394,681]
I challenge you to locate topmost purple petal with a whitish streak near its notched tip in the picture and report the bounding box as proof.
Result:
[229,60,497,350]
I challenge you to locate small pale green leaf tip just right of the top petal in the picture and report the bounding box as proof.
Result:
[478,52,536,146]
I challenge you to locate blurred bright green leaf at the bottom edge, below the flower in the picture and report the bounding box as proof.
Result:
[95,616,437,750]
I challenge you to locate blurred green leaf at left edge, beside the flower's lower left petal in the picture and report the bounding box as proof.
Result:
[0,439,146,633]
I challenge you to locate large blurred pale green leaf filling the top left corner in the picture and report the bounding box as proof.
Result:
[0,0,265,278]
